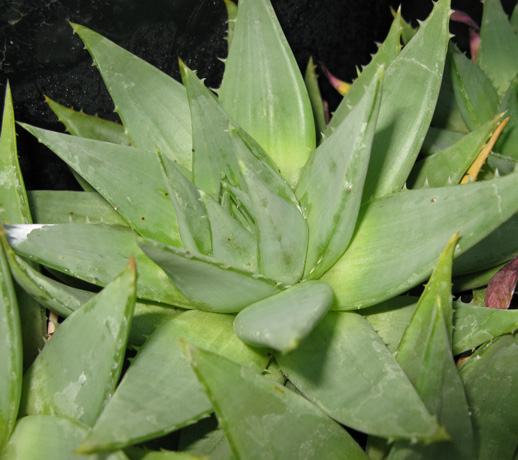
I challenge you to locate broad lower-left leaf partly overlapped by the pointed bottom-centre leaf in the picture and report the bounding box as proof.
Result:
[81,311,268,452]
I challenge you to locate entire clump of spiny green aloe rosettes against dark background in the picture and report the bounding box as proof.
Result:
[0,0,518,460]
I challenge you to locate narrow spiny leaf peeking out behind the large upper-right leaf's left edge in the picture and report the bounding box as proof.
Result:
[325,9,401,136]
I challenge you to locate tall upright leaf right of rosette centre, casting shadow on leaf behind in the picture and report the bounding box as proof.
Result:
[296,69,383,279]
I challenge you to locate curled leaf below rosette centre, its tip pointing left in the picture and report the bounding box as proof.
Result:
[139,239,283,313]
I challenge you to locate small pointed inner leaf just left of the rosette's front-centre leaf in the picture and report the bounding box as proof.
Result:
[202,193,257,272]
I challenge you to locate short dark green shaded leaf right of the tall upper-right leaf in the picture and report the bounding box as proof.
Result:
[449,43,500,131]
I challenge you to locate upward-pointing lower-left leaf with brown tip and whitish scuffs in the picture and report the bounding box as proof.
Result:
[20,260,136,425]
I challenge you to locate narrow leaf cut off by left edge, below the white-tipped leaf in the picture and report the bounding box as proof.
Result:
[0,239,23,450]
